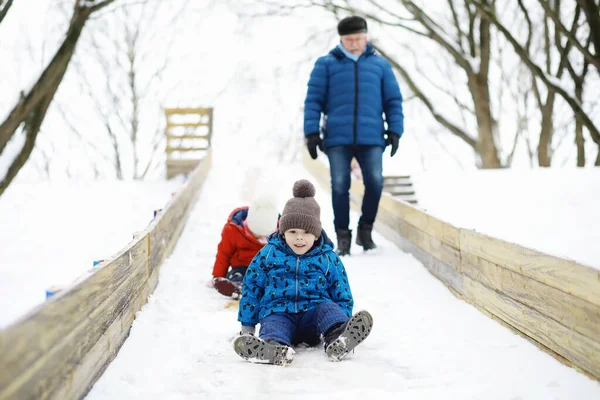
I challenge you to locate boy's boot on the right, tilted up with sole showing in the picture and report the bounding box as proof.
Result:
[324,311,373,361]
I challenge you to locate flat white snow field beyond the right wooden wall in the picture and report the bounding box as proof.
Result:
[412,168,600,269]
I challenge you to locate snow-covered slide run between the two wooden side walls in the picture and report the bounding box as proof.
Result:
[87,158,600,400]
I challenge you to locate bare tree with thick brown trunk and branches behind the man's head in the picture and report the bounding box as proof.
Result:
[248,0,502,168]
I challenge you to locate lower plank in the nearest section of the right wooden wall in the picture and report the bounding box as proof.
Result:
[463,275,600,379]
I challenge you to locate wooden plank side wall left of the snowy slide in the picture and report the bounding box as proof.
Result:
[0,152,211,400]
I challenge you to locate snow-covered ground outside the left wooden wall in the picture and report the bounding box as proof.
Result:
[0,180,181,328]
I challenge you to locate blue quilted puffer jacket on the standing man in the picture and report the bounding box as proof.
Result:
[304,44,404,149]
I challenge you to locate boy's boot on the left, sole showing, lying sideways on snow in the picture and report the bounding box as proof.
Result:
[233,335,295,366]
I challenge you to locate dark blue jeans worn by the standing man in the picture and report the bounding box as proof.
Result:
[326,146,384,230]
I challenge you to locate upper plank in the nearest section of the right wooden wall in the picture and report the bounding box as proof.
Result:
[460,229,600,306]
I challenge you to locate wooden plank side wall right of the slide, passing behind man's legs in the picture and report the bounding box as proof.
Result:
[304,154,600,380]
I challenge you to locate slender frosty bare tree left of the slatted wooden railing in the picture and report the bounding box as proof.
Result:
[65,0,197,179]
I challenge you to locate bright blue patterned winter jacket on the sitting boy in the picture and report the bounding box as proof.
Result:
[238,230,354,326]
